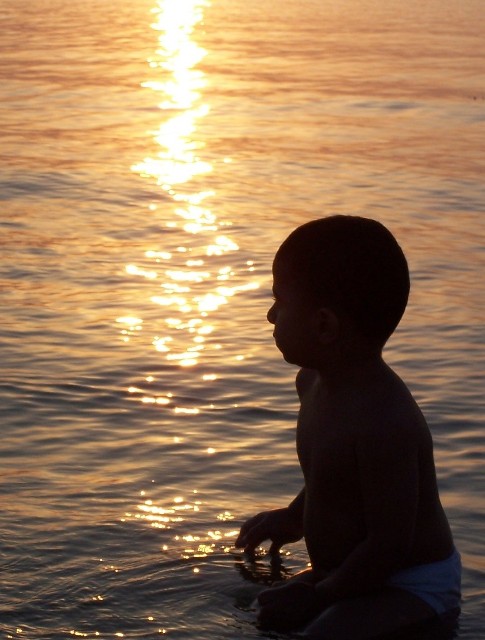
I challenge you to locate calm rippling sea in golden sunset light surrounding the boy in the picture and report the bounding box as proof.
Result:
[0,0,485,640]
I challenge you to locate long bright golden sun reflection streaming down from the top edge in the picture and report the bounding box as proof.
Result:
[125,0,259,378]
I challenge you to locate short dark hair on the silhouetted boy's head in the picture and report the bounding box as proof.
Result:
[275,215,410,346]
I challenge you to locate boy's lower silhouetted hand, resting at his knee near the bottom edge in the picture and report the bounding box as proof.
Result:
[258,581,321,631]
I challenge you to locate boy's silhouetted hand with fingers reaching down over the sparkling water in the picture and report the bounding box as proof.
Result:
[235,508,303,553]
